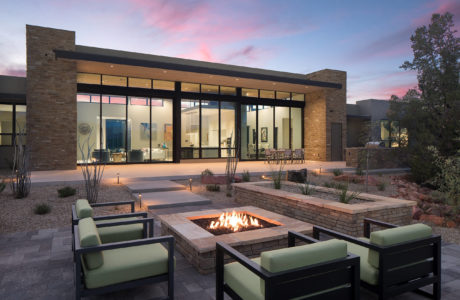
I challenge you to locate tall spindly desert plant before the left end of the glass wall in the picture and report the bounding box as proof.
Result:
[78,127,105,203]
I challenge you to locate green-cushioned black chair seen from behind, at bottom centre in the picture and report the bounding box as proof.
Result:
[216,231,359,300]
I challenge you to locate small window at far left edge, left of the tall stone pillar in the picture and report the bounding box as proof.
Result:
[0,104,26,146]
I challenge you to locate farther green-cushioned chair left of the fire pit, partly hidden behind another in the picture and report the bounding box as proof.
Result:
[72,199,153,249]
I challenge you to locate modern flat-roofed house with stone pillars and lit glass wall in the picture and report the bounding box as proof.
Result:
[0,25,347,170]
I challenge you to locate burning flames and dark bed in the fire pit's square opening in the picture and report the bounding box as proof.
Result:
[189,211,282,235]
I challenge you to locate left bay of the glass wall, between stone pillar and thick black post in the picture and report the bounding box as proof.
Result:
[77,93,172,163]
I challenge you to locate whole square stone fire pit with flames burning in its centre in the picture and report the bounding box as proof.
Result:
[159,206,313,274]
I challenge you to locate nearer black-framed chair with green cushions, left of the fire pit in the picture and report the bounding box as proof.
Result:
[74,218,174,300]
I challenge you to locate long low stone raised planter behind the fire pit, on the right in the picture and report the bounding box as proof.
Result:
[233,182,416,236]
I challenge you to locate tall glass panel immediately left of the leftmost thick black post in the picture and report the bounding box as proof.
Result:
[151,98,173,161]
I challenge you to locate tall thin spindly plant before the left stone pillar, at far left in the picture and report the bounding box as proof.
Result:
[10,125,30,198]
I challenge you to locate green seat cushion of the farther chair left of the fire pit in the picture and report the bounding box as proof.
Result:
[96,217,144,244]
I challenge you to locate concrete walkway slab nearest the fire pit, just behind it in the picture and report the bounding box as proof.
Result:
[137,190,211,209]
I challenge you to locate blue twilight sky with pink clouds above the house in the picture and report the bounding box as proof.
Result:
[0,0,460,103]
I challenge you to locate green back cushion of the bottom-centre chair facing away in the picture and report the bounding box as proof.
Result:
[260,239,347,293]
